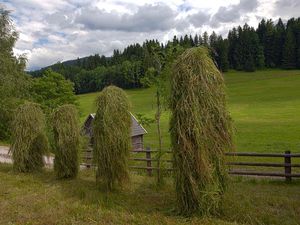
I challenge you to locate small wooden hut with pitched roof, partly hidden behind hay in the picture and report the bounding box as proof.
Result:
[82,113,147,166]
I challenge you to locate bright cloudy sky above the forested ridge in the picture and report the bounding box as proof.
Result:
[0,0,300,70]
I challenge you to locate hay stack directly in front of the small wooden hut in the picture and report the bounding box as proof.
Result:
[93,86,131,190]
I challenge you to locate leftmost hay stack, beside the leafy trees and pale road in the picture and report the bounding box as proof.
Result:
[11,103,48,172]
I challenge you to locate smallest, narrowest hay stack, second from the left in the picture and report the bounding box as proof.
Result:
[52,104,80,178]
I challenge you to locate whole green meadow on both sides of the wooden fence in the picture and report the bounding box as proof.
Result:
[0,70,300,225]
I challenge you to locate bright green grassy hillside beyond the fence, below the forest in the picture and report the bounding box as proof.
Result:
[79,70,300,152]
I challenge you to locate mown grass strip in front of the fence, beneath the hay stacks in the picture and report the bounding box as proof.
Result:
[0,164,300,225]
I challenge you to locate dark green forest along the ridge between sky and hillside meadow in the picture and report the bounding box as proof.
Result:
[29,18,300,94]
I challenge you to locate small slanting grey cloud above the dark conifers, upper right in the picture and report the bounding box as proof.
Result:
[210,0,258,27]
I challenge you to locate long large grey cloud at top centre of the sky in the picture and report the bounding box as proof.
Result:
[75,4,176,32]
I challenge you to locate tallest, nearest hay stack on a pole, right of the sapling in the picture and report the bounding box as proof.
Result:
[170,47,233,215]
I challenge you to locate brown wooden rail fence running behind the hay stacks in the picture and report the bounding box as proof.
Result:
[81,147,300,181]
